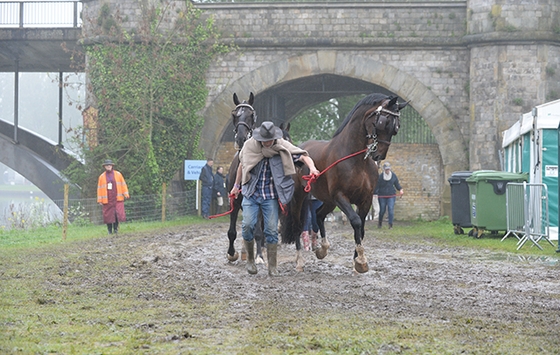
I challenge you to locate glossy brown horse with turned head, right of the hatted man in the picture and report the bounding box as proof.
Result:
[281,94,407,273]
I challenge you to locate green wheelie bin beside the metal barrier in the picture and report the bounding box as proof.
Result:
[466,170,529,238]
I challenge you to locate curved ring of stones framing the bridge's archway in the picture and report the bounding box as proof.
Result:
[200,51,469,179]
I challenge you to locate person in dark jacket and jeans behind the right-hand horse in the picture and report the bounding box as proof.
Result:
[373,162,404,229]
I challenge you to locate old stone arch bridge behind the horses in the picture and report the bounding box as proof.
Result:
[0,0,560,217]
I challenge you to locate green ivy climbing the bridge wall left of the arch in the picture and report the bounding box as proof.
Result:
[66,1,230,197]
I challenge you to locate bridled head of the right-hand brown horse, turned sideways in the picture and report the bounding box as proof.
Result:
[364,97,408,161]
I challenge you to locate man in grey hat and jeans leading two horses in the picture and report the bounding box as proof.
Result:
[231,121,319,276]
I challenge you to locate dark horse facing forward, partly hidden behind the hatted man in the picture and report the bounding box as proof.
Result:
[226,92,291,262]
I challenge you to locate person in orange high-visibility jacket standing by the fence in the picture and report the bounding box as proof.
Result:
[97,159,130,234]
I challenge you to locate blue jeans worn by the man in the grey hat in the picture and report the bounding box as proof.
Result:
[241,196,278,244]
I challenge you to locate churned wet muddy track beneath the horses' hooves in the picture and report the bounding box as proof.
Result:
[122,222,560,330]
